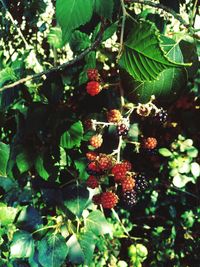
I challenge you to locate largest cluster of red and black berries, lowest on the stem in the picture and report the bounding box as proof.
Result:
[86,154,148,209]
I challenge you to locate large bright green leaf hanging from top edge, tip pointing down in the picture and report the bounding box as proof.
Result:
[56,0,94,41]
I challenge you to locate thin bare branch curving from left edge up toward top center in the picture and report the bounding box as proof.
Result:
[0,26,103,92]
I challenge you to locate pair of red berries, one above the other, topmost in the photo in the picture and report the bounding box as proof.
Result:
[86,69,102,96]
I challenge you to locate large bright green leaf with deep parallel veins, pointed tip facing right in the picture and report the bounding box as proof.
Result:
[119,22,190,82]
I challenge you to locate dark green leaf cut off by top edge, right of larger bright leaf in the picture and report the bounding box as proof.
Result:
[94,0,114,19]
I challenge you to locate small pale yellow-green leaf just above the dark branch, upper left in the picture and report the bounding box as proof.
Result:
[47,27,64,48]
